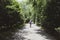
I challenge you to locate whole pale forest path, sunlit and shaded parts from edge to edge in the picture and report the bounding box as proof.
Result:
[13,24,55,40]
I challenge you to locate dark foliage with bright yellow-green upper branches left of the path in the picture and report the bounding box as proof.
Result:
[0,0,24,29]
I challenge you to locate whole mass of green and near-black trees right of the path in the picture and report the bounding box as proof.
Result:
[29,0,60,31]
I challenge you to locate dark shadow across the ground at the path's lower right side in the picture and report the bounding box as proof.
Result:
[37,30,60,40]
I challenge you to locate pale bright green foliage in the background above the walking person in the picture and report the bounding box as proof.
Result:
[17,1,33,23]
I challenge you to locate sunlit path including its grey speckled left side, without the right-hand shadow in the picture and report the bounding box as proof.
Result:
[11,24,54,40]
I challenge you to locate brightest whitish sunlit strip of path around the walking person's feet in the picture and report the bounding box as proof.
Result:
[21,24,51,40]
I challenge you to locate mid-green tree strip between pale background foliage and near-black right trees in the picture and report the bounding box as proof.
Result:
[30,0,46,25]
